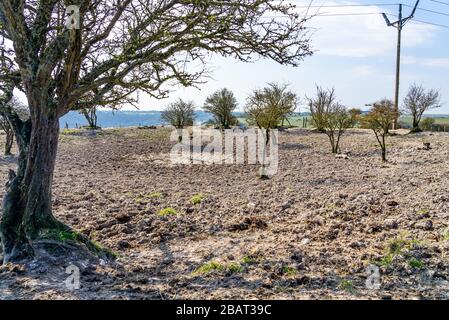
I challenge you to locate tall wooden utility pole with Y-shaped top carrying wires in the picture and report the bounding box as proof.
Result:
[382,0,420,129]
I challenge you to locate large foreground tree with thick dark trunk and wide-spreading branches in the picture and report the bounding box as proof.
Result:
[0,0,311,262]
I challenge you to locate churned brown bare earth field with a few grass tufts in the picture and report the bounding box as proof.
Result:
[0,129,449,299]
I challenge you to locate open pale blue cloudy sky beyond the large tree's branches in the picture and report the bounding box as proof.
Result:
[136,0,449,114]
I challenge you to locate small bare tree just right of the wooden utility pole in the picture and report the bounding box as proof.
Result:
[404,84,441,132]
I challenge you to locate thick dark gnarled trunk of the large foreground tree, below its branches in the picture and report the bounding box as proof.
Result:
[0,107,63,263]
